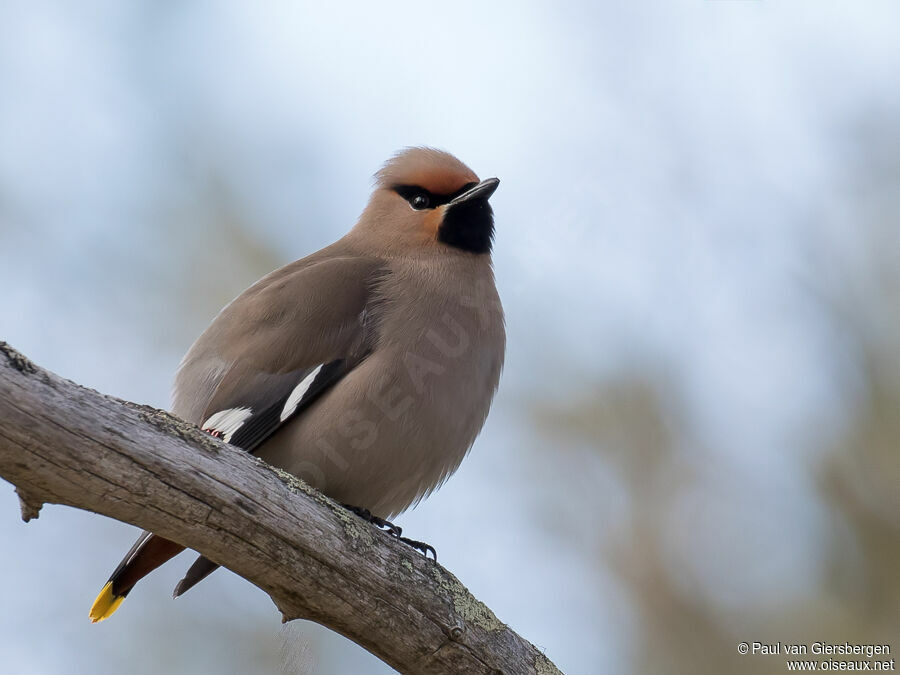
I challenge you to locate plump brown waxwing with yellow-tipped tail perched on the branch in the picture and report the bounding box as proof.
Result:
[90,147,506,623]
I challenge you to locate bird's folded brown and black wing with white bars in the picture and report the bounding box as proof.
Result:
[173,257,385,452]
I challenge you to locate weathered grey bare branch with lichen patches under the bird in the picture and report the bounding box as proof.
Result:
[0,342,559,675]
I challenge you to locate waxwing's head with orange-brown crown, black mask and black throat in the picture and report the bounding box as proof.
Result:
[357,148,500,254]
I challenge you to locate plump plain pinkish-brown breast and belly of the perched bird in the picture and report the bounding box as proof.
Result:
[260,264,505,516]
